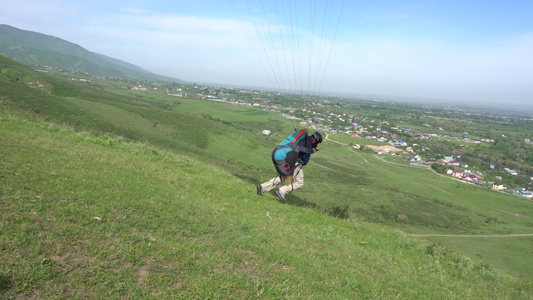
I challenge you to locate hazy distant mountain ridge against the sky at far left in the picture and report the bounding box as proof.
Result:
[0,24,183,82]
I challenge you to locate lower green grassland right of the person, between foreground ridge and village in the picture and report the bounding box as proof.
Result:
[298,135,533,277]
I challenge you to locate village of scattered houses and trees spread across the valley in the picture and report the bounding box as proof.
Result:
[125,83,533,199]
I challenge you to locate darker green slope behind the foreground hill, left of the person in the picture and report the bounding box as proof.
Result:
[0,56,264,175]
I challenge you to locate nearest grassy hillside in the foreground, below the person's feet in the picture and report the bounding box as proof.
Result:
[0,114,533,299]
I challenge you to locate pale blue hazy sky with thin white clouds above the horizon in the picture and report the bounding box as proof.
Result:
[0,0,533,104]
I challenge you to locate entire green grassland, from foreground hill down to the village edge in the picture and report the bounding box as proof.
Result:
[0,56,533,299]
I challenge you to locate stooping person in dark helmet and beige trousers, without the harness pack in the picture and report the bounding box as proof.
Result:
[257,132,322,202]
